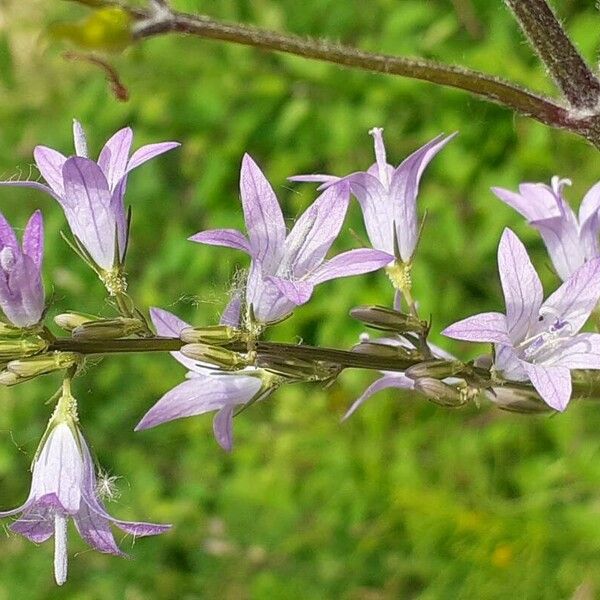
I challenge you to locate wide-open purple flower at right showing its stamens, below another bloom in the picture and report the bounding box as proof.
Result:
[442,229,600,411]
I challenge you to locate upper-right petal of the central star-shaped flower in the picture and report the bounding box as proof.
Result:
[278,182,350,278]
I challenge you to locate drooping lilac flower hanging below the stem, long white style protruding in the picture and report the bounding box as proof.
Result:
[0,419,170,585]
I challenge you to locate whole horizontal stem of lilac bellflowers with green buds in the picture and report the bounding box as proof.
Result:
[0,122,600,584]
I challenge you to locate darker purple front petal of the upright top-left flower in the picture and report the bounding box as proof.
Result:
[63,157,116,269]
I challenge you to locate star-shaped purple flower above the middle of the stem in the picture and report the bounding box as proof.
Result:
[189,154,393,323]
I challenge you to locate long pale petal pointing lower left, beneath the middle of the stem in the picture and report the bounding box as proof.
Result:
[135,375,262,431]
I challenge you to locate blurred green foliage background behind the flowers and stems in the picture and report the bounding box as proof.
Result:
[0,0,600,600]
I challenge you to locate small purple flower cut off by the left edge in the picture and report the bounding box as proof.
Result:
[0,210,44,327]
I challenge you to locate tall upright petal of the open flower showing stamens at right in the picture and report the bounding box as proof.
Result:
[498,229,544,341]
